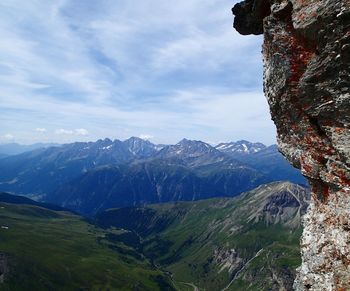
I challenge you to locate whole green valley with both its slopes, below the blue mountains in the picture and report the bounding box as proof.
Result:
[0,182,309,290]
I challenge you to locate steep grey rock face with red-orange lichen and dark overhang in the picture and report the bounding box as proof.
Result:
[232,0,350,290]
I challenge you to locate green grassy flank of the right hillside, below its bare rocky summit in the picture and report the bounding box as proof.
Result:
[97,182,308,290]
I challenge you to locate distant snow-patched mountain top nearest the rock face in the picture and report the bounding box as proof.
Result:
[215,140,266,155]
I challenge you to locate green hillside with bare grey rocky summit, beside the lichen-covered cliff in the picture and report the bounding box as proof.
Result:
[96,183,308,290]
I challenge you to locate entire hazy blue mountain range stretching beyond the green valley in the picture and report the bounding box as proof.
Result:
[0,137,305,215]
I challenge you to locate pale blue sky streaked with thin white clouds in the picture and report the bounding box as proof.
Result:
[0,0,275,144]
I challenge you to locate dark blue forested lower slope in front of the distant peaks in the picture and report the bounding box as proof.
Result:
[46,160,268,216]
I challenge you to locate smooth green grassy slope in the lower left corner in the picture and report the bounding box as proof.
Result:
[0,203,171,291]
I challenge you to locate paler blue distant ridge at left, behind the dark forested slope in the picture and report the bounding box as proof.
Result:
[0,137,163,194]
